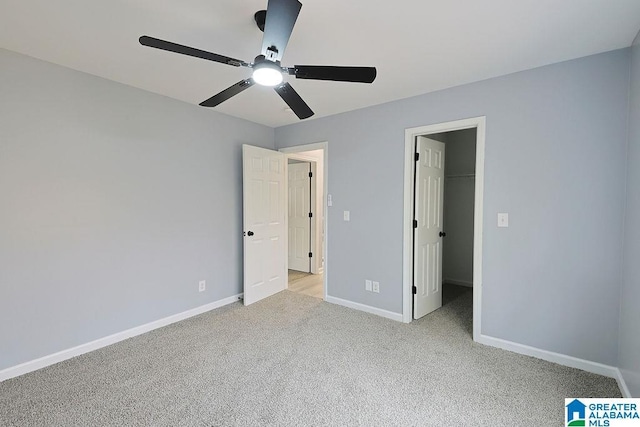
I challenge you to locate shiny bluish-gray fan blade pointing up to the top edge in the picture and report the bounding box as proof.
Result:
[262,0,302,61]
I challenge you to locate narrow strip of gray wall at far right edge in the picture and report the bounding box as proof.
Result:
[620,33,640,397]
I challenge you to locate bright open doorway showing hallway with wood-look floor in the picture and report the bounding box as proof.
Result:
[280,142,327,299]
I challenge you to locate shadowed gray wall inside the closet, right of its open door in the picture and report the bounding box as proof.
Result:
[442,129,476,285]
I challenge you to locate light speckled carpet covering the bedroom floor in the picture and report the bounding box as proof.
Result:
[0,291,620,427]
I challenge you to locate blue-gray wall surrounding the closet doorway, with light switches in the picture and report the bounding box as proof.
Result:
[275,49,630,365]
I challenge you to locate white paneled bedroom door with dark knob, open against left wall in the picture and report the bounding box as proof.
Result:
[242,145,287,305]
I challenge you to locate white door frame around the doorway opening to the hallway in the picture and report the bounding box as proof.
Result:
[278,141,329,301]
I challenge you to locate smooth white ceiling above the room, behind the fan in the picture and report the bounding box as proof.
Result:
[0,0,640,127]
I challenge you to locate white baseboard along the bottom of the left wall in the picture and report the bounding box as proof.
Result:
[0,294,243,382]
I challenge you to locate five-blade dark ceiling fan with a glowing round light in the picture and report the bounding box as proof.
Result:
[140,0,376,119]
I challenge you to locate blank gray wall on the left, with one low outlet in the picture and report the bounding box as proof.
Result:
[0,50,274,369]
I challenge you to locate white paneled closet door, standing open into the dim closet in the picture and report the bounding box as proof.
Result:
[413,136,444,319]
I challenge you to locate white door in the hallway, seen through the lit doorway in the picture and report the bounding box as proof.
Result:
[289,162,312,273]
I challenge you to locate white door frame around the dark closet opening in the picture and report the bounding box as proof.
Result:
[402,116,486,341]
